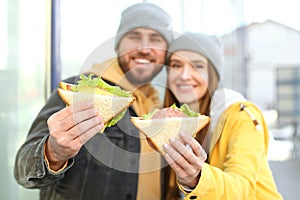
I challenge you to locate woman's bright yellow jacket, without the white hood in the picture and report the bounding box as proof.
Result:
[181,102,282,200]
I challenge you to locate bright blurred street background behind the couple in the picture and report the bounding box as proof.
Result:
[0,0,300,200]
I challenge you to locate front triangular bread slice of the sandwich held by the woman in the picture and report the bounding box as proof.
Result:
[131,115,210,154]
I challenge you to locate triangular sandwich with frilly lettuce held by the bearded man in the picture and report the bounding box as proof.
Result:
[58,74,135,132]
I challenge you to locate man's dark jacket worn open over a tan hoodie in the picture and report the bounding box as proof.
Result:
[14,77,176,200]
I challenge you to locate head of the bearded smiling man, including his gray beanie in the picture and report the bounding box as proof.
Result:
[115,1,173,85]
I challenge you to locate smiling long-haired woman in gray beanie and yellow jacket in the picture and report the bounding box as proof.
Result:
[164,33,282,200]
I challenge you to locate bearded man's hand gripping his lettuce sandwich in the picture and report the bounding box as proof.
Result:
[45,102,104,170]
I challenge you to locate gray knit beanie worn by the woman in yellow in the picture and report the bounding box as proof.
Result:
[167,32,224,77]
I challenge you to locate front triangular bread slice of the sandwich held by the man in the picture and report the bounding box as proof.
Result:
[58,88,135,124]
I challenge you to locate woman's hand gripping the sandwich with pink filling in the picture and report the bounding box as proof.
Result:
[164,133,207,188]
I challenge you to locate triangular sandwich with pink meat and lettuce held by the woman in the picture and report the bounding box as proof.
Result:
[131,104,210,154]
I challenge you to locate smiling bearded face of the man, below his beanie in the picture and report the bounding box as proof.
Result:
[117,28,168,86]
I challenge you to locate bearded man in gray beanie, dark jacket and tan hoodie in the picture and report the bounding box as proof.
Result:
[14,3,177,200]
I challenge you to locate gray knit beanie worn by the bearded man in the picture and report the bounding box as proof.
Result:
[115,2,173,49]
